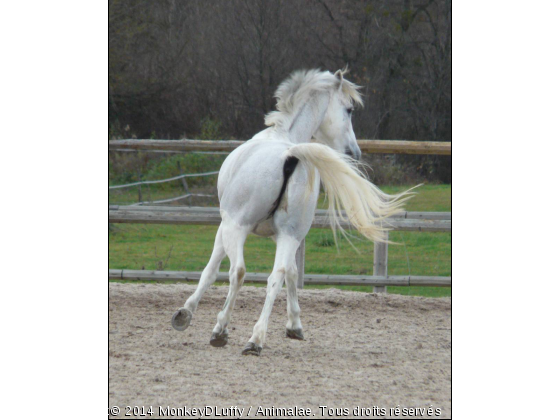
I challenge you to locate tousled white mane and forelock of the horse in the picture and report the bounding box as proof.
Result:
[264,68,363,128]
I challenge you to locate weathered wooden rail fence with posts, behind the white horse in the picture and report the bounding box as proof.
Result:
[109,139,451,292]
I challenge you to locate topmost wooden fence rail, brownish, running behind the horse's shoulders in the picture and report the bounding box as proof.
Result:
[109,139,451,155]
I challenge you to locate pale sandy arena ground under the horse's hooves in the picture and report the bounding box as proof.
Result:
[109,283,451,418]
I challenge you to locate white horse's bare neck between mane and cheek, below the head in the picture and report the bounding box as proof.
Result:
[288,92,330,143]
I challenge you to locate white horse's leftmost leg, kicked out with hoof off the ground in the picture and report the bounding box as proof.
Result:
[171,225,226,331]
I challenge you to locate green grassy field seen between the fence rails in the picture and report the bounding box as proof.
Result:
[109,185,451,297]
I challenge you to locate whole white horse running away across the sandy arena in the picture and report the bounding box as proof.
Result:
[172,70,412,356]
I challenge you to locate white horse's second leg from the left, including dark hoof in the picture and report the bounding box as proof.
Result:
[210,223,249,347]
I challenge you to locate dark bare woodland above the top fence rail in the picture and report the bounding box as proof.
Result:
[109,0,451,180]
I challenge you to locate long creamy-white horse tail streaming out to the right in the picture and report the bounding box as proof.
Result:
[287,143,411,242]
